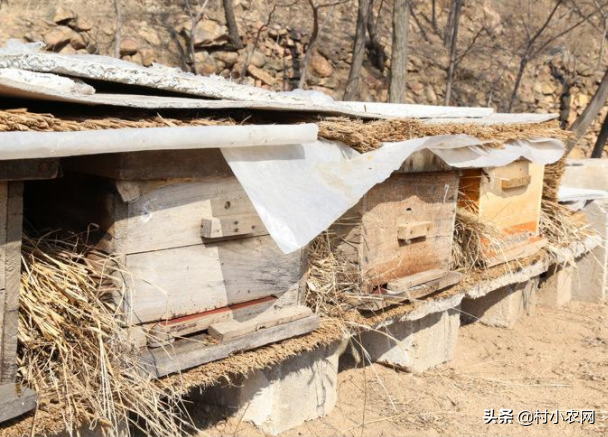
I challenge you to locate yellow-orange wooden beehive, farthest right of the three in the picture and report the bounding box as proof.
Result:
[458,160,546,266]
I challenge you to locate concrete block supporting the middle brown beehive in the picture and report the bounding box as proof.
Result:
[361,308,460,373]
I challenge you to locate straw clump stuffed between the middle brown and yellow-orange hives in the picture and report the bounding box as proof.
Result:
[451,208,501,273]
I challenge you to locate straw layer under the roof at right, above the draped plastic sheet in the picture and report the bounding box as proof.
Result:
[317,117,570,153]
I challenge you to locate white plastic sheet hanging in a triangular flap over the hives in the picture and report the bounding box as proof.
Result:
[222,135,564,253]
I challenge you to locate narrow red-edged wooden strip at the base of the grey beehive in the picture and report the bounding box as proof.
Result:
[144,296,277,347]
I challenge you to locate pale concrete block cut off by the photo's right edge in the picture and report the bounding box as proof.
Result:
[572,200,608,302]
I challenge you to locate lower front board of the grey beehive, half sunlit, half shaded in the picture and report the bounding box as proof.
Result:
[126,236,305,324]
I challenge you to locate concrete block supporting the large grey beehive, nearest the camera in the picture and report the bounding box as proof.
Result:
[202,343,342,435]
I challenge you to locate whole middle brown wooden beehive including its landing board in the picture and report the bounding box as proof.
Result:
[329,171,459,309]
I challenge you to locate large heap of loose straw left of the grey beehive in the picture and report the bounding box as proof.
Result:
[18,230,185,436]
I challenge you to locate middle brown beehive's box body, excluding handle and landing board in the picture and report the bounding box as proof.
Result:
[330,172,458,290]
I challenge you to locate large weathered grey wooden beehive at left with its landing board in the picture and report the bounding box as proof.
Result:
[29,149,317,374]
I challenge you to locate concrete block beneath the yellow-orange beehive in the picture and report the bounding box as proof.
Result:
[462,278,538,328]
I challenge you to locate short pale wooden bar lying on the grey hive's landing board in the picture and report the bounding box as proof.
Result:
[209,306,312,341]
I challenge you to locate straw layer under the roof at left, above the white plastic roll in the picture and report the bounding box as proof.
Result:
[0,109,235,132]
